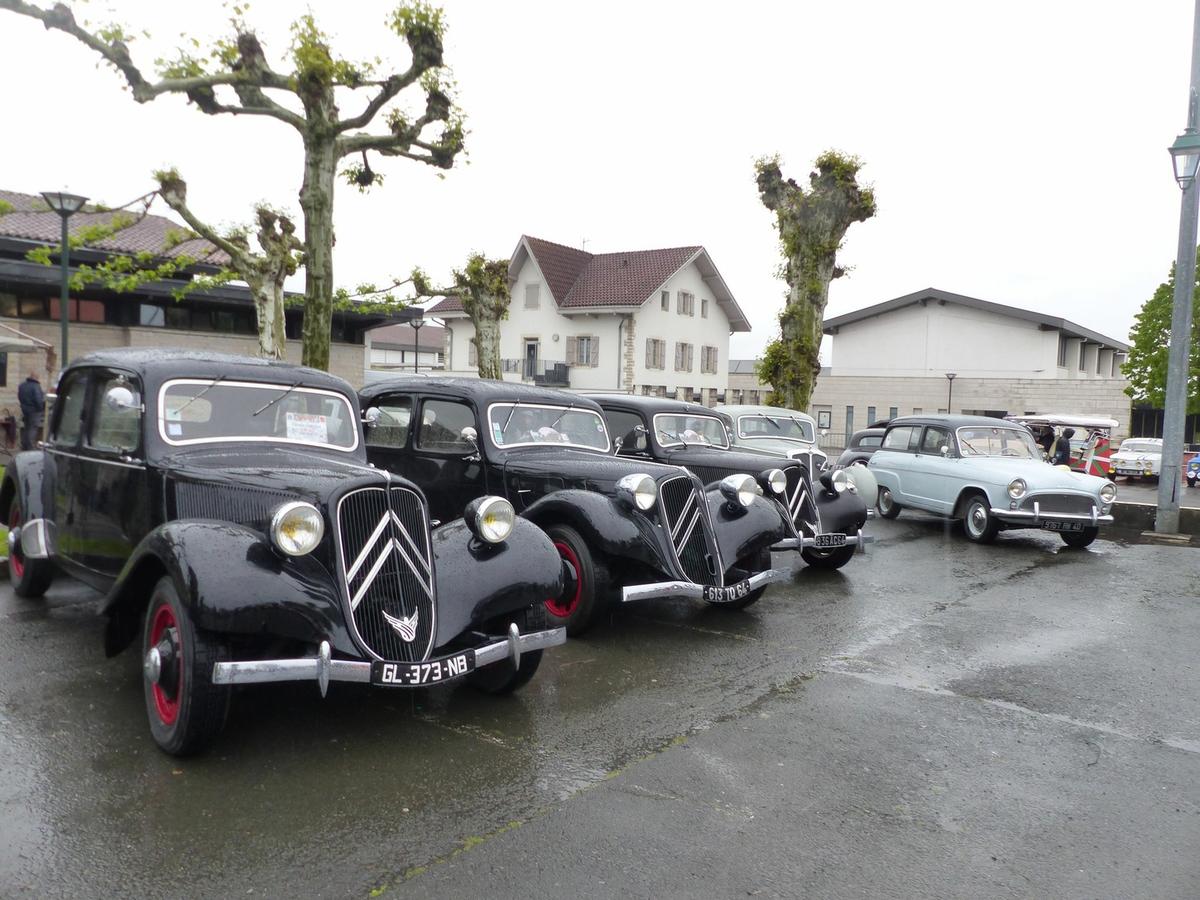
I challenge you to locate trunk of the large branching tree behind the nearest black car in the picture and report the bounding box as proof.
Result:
[300,136,337,371]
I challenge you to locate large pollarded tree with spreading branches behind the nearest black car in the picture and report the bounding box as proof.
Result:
[0,0,464,368]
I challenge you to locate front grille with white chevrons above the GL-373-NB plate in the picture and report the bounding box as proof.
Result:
[337,487,437,662]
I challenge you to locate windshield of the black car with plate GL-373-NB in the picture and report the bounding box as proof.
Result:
[158,378,359,450]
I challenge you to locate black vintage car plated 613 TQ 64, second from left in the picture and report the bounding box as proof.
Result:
[360,377,785,635]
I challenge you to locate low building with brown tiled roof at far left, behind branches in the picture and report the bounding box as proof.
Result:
[0,191,396,416]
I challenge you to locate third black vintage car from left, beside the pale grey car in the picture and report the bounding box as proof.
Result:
[592,394,874,569]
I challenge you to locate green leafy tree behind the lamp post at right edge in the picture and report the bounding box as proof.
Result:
[1121,254,1200,413]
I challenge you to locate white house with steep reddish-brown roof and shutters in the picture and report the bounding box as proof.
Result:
[428,235,750,401]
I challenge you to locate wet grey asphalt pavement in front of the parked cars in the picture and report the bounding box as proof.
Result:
[0,514,1200,898]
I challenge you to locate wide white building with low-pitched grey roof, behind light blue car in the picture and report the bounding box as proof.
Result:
[730,288,1130,449]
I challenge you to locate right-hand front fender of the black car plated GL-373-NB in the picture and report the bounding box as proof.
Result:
[433,517,563,647]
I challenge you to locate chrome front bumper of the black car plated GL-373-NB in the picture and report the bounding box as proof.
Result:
[212,624,566,697]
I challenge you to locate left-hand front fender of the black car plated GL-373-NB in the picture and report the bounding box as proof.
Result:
[100,520,352,659]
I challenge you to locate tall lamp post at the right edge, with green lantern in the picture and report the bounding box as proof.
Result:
[1154,0,1200,534]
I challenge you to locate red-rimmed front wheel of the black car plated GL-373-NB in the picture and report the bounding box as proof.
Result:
[142,576,230,756]
